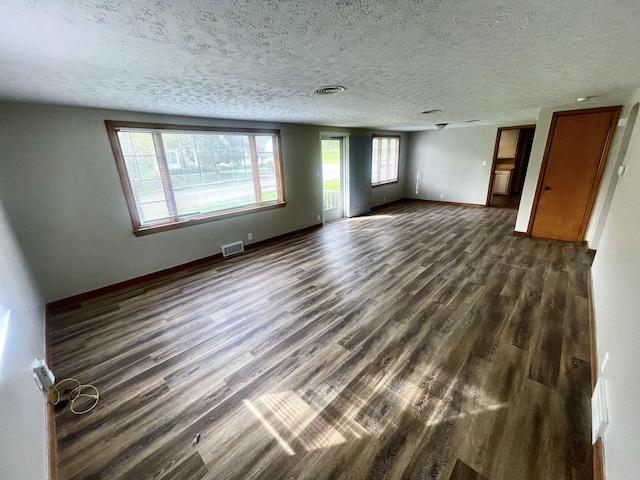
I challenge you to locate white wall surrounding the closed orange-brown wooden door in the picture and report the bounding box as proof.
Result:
[515,99,628,238]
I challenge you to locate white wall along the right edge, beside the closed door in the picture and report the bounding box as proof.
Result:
[592,86,640,480]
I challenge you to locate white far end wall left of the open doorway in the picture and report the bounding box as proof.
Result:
[405,125,498,205]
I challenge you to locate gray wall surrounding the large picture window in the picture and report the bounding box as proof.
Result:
[0,103,406,302]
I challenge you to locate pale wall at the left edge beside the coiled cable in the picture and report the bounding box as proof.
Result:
[0,200,48,480]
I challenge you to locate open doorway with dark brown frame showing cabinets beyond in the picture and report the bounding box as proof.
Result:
[486,125,536,210]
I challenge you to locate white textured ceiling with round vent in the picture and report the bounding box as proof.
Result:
[0,0,640,130]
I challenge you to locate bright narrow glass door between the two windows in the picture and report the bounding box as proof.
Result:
[320,134,346,223]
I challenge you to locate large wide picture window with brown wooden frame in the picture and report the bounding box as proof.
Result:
[106,121,284,235]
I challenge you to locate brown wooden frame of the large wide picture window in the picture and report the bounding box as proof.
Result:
[105,120,287,236]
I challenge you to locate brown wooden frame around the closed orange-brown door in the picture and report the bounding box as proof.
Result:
[527,105,622,243]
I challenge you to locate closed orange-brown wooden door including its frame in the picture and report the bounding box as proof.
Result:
[529,107,620,242]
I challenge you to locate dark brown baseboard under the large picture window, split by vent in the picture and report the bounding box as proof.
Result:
[46,224,322,311]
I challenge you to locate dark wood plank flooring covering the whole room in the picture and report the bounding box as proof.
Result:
[50,201,593,480]
